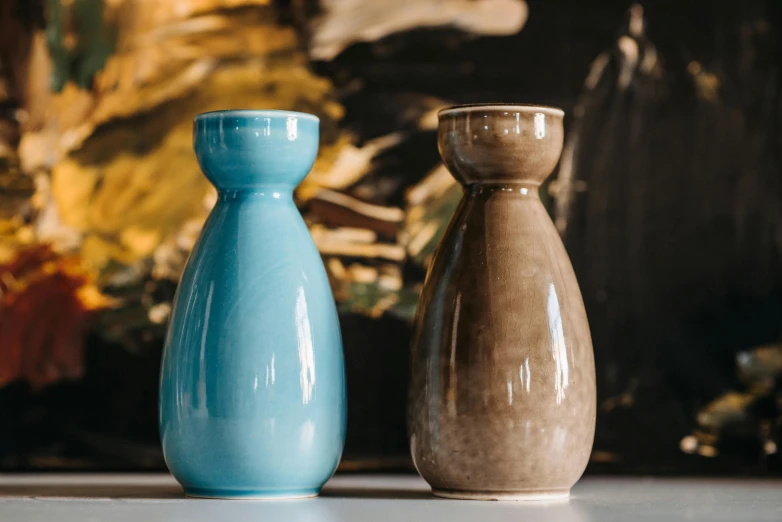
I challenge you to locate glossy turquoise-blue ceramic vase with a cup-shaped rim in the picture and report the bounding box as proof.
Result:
[159,111,346,499]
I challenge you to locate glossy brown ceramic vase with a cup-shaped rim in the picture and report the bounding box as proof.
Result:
[408,105,596,500]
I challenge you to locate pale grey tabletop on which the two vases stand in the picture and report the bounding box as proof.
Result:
[0,474,782,522]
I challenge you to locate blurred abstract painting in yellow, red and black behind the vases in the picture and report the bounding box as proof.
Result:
[0,0,782,475]
